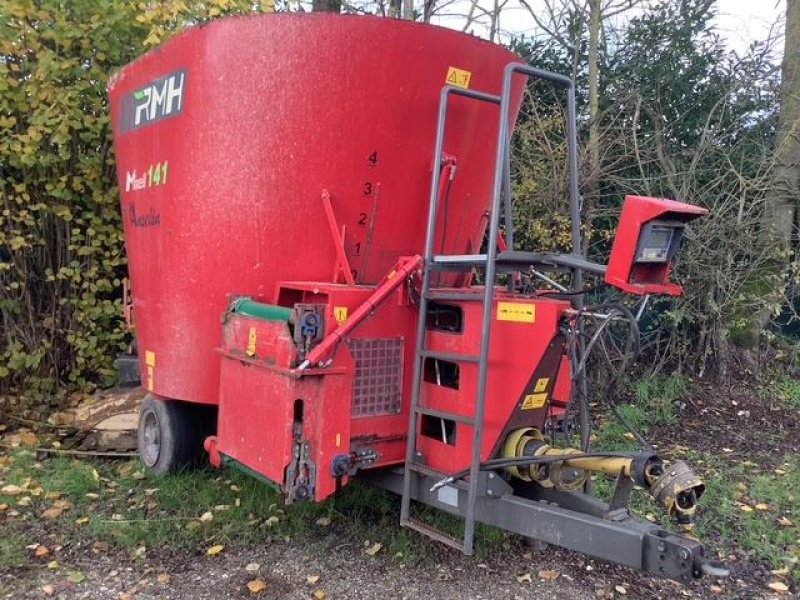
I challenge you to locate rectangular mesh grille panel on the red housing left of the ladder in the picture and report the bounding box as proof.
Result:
[347,338,403,417]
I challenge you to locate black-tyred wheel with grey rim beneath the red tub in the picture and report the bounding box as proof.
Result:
[137,394,203,477]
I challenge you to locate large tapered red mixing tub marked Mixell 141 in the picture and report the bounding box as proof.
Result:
[109,14,522,404]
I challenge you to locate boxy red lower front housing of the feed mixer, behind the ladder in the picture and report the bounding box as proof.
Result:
[207,274,570,500]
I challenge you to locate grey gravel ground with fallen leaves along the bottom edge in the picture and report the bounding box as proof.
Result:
[0,541,597,600]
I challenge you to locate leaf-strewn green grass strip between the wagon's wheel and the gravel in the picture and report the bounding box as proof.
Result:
[0,450,508,568]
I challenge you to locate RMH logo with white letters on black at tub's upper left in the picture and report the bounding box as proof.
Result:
[123,70,187,131]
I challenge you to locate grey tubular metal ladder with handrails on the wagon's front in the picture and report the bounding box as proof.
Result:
[400,63,580,555]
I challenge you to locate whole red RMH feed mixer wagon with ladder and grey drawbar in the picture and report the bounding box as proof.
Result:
[109,14,725,580]
